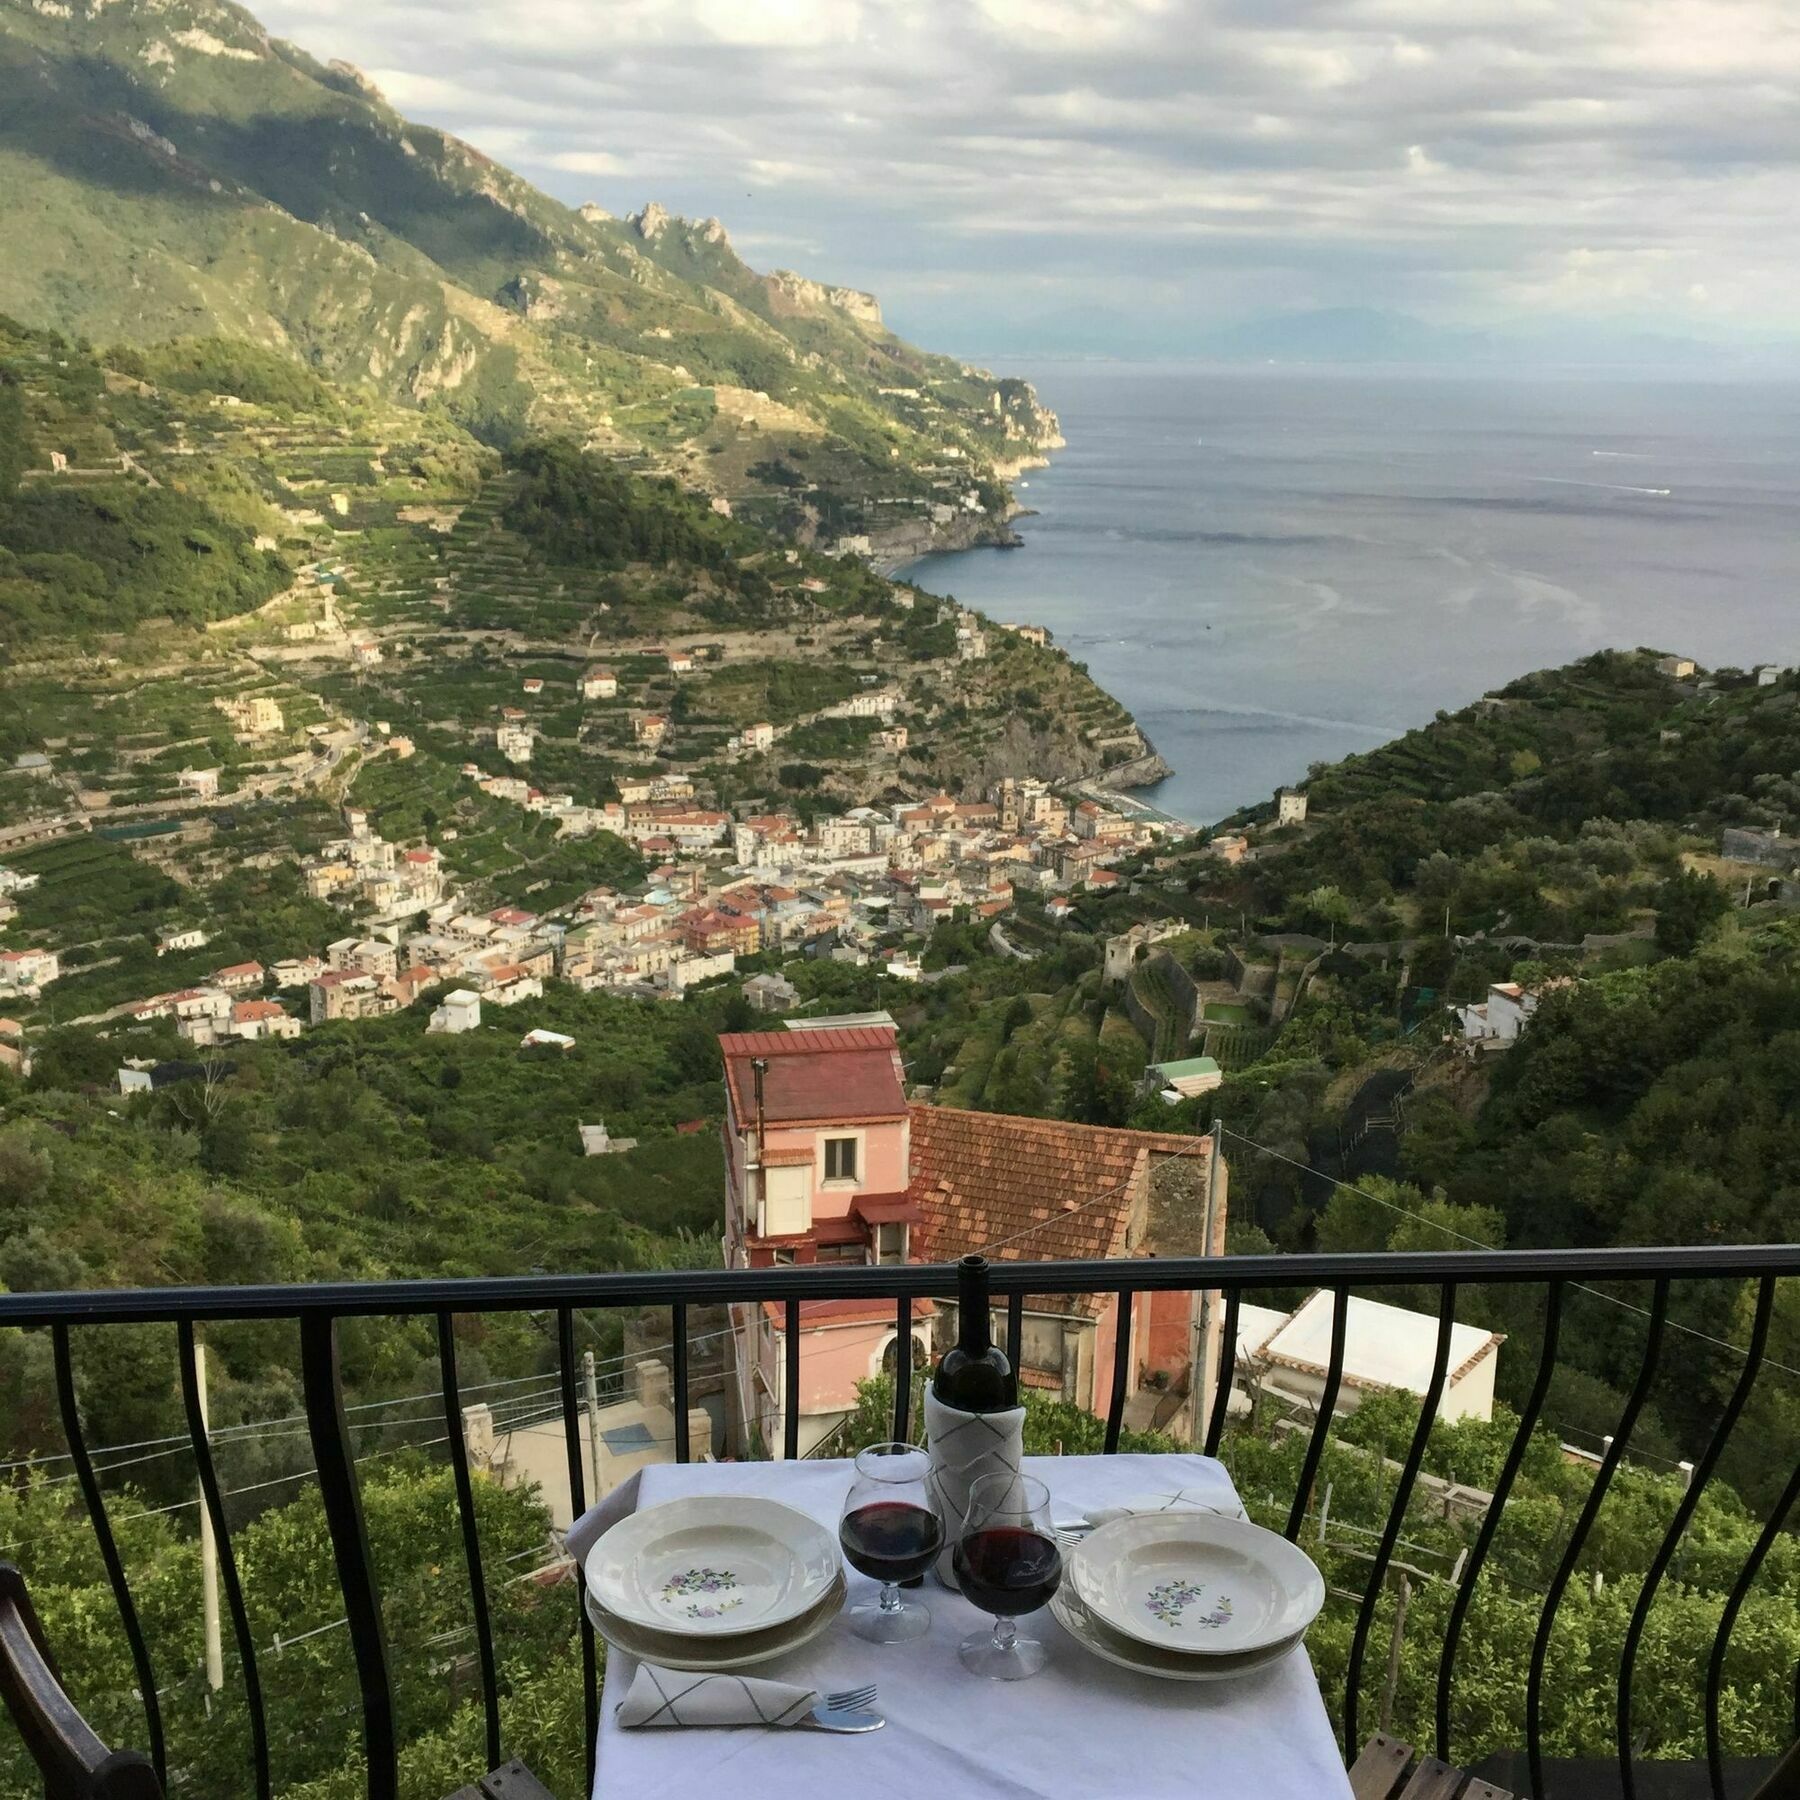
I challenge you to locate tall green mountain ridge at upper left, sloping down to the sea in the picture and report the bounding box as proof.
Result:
[0,0,1055,527]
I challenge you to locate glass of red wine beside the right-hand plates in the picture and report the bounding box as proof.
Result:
[952,1469,1062,1681]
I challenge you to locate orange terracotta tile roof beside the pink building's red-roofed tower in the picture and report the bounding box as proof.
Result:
[907,1105,1208,1312]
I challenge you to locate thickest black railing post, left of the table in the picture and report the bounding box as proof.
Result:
[301,1312,400,1800]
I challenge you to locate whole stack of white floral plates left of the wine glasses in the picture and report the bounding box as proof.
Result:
[583,1494,844,1672]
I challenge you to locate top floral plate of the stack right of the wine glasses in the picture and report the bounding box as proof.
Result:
[1069,1510,1325,1656]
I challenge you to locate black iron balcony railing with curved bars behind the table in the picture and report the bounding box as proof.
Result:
[0,1244,1800,1800]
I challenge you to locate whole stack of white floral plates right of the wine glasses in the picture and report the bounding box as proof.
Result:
[1049,1508,1325,1681]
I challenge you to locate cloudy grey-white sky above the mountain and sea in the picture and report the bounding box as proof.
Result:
[256,0,1800,353]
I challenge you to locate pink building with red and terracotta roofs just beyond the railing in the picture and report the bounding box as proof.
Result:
[720,1026,1226,1454]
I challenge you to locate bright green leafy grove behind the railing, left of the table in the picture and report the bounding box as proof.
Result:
[0,1442,583,1800]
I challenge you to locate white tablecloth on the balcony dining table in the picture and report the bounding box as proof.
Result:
[569,1456,1350,1800]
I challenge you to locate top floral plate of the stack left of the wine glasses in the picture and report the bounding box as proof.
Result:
[585,1494,841,1638]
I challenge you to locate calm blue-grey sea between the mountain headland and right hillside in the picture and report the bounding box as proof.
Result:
[904,358,1800,824]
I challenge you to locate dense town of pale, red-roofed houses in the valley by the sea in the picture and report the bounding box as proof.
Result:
[31,770,1181,1048]
